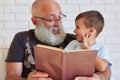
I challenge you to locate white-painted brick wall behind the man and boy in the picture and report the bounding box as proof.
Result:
[0,0,120,80]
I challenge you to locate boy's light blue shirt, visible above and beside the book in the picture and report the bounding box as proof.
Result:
[65,40,112,66]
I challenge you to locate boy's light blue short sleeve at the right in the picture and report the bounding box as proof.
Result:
[98,46,112,66]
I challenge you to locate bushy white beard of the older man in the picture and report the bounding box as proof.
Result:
[35,24,66,45]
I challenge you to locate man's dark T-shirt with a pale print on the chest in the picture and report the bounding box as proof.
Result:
[6,30,75,77]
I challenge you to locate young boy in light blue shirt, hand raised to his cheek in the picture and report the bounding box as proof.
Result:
[65,11,109,72]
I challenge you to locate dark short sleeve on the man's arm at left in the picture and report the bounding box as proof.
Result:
[6,34,24,62]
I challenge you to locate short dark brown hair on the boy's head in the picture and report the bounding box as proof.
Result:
[75,10,104,36]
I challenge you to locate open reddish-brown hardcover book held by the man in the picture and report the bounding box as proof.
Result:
[34,45,97,80]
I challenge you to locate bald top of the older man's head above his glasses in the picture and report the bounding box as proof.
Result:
[32,0,61,17]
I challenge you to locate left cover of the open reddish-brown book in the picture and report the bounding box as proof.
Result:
[34,47,63,80]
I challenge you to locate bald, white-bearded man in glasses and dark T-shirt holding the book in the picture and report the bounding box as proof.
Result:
[6,0,110,80]
